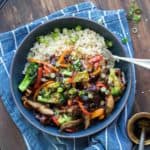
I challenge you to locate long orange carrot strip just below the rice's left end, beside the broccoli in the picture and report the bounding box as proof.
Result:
[28,58,59,72]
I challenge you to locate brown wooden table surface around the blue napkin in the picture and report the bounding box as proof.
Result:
[0,0,150,150]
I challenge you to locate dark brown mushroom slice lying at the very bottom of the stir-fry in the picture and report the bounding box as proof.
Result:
[60,119,83,131]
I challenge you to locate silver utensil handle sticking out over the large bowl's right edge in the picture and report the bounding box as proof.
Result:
[113,55,150,69]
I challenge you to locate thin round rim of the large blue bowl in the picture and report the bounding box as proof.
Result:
[10,16,132,139]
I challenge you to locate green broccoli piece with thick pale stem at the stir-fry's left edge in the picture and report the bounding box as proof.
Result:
[18,63,38,92]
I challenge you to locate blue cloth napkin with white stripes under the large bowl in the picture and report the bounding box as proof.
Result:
[0,2,136,150]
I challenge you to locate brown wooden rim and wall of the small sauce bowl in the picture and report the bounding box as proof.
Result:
[127,112,150,145]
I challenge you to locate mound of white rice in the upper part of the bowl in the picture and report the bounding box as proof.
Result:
[28,29,106,60]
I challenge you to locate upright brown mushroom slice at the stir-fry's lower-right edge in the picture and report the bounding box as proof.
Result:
[106,95,115,115]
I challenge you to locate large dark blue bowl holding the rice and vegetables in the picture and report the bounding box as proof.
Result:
[11,17,131,138]
